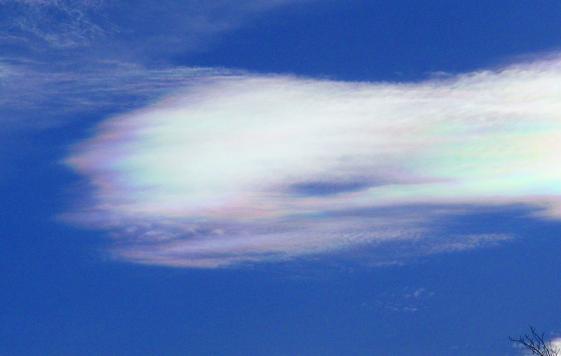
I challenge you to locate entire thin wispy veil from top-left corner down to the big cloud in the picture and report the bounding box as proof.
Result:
[0,0,309,131]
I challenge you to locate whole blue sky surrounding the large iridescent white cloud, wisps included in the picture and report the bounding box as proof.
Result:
[0,0,561,356]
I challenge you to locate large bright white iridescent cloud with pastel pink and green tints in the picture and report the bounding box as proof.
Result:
[65,57,561,267]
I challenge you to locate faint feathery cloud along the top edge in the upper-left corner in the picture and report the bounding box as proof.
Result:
[0,0,310,50]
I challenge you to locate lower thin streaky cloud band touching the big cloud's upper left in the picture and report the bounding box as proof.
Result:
[0,58,232,132]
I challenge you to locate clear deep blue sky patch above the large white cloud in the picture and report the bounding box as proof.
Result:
[180,0,561,81]
